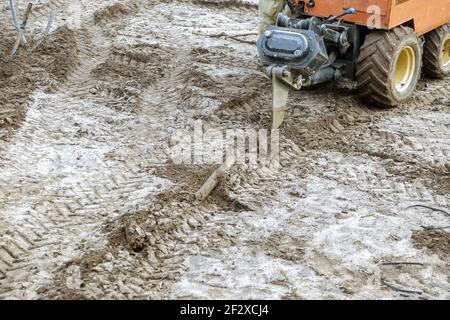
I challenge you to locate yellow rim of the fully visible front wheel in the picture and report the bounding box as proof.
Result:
[394,46,416,93]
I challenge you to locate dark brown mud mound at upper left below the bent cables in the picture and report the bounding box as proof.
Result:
[0,27,78,139]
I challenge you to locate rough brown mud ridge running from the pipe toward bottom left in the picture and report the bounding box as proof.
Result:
[46,165,248,299]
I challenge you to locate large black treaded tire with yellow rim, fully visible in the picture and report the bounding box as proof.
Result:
[356,26,422,107]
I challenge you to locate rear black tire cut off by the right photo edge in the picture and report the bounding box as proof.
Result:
[423,23,450,79]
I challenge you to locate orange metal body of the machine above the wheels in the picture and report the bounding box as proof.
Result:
[305,0,450,35]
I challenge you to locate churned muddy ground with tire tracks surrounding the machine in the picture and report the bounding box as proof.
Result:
[0,0,450,299]
